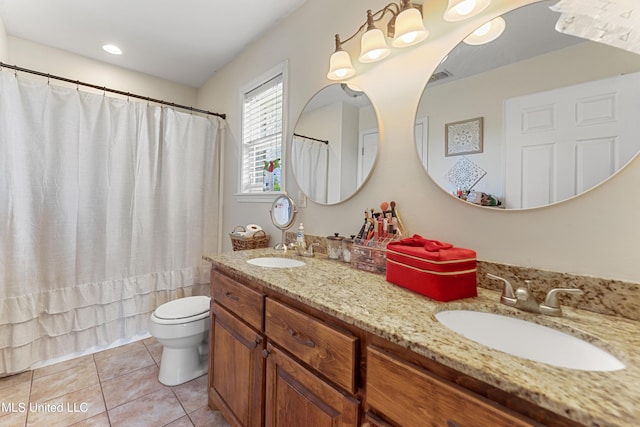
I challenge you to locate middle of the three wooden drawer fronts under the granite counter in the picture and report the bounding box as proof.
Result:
[265,298,358,394]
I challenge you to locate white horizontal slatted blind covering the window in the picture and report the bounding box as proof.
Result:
[242,73,284,193]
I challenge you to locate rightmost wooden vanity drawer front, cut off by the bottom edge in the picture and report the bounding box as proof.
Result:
[366,347,539,427]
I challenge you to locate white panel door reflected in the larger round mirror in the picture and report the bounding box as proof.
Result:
[504,73,640,208]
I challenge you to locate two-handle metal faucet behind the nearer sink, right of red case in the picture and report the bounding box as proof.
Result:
[487,273,584,317]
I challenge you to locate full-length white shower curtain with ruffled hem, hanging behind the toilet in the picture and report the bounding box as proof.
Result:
[0,71,224,376]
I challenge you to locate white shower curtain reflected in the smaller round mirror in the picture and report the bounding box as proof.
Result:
[291,136,329,203]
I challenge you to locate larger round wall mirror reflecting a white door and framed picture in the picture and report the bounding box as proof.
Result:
[416,0,640,209]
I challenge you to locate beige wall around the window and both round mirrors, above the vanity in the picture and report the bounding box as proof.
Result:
[198,0,640,282]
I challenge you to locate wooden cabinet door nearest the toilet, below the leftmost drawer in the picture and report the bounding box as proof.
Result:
[209,303,265,427]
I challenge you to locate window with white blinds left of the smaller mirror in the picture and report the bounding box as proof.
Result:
[241,62,285,198]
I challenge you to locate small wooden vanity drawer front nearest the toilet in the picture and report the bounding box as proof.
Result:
[211,272,264,331]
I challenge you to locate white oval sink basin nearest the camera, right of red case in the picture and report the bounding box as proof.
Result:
[435,310,624,371]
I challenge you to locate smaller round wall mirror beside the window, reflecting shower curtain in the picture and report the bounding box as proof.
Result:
[291,83,379,205]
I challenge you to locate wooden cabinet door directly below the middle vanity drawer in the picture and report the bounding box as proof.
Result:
[265,344,359,427]
